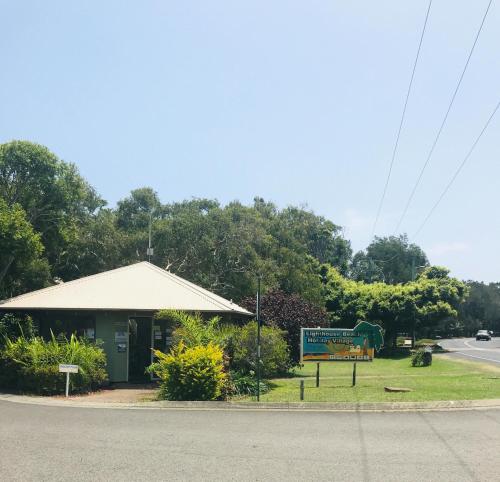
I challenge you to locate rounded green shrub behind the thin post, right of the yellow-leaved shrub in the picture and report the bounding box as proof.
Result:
[231,321,292,378]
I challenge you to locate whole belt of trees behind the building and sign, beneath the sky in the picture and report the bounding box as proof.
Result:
[0,141,490,340]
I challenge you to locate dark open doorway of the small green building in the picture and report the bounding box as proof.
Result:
[128,318,152,383]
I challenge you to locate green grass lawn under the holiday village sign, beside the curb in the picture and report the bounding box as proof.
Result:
[244,354,500,402]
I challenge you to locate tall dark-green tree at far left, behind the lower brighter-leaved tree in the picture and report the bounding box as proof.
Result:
[0,141,104,286]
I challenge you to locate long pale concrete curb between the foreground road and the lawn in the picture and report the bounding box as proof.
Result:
[0,393,500,412]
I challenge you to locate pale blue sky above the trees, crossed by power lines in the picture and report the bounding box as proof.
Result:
[0,0,500,282]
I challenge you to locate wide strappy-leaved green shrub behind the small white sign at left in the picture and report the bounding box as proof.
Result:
[0,335,107,395]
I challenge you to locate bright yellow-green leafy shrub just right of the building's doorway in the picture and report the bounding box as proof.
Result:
[148,341,227,400]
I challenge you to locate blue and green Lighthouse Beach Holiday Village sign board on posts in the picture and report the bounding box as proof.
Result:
[300,321,384,362]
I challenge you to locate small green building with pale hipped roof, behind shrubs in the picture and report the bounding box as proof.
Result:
[0,262,252,382]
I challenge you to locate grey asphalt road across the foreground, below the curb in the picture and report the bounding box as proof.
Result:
[0,402,500,482]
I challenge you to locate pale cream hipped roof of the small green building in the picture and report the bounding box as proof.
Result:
[0,261,252,315]
